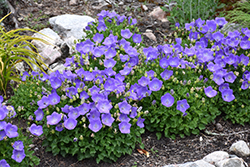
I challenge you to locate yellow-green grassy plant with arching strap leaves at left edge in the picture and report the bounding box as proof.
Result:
[0,15,49,94]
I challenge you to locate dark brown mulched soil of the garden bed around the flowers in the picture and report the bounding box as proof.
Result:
[1,1,250,167]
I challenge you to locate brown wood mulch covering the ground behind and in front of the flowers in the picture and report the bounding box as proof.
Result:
[0,0,250,167]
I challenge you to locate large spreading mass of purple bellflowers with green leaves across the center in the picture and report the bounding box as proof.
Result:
[3,11,250,166]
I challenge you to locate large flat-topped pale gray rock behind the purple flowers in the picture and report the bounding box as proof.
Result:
[49,14,95,39]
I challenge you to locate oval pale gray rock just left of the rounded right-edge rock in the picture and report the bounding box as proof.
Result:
[203,151,229,164]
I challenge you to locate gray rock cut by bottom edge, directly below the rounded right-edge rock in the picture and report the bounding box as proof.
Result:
[215,158,246,167]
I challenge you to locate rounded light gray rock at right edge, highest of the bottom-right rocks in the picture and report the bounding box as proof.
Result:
[230,140,250,157]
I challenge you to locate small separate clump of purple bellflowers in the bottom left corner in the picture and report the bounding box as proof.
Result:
[0,96,40,167]
